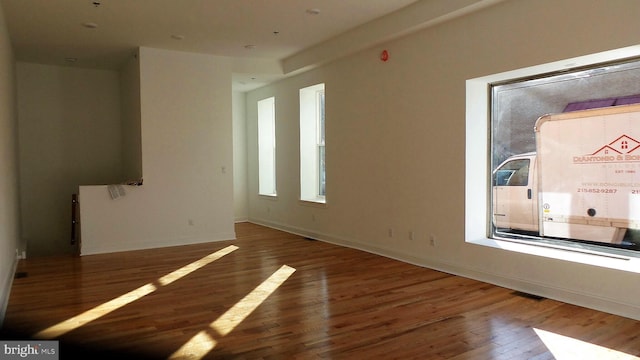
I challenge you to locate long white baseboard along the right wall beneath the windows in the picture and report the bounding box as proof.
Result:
[249,219,640,320]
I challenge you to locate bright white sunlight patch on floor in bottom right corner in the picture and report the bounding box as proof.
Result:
[533,328,640,360]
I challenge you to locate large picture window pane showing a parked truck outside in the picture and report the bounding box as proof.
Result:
[487,58,640,253]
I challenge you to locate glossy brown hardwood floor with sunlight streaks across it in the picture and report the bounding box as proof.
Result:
[0,223,640,359]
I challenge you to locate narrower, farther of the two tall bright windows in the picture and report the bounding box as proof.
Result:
[258,97,276,196]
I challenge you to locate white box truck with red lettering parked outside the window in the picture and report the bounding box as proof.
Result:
[492,104,640,244]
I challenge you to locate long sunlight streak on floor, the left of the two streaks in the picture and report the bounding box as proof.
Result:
[34,245,238,339]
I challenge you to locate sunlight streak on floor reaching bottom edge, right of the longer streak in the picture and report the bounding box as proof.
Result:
[169,265,296,359]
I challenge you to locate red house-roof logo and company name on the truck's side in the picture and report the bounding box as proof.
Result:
[573,135,640,164]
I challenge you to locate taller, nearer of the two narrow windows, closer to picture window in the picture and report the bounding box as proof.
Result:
[300,84,326,203]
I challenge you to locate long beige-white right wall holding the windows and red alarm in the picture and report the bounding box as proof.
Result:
[247,0,640,318]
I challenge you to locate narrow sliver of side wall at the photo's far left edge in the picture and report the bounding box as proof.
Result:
[0,1,21,327]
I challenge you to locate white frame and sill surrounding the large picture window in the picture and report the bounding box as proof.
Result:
[465,45,640,273]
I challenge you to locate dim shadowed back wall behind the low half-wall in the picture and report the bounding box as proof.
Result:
[17,62,123,256]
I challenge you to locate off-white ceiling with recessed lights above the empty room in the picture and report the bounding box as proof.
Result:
[0,0,499,90]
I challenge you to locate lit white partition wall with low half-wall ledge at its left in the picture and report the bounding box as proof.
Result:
[80,48,235,254]
